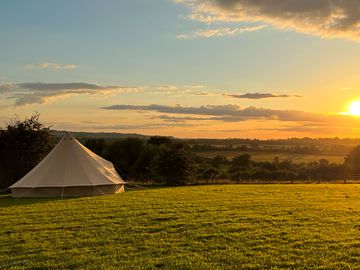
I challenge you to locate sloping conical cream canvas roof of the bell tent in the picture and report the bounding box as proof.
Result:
[10,133,126,188]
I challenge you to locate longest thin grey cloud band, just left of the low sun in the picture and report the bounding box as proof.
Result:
[102,104,327,122]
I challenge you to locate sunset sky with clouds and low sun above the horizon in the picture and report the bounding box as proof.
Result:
[0,0,360,139]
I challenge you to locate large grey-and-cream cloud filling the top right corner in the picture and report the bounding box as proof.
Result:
[176,0,360,40]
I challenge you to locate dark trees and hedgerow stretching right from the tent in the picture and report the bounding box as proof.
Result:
[85,137,360,185]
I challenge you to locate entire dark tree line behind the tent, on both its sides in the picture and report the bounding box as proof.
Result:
[0,115,360,189]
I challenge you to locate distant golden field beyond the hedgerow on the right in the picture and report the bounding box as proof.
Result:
[196,151,345,163]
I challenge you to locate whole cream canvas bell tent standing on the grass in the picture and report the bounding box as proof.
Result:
[10,133,126,197]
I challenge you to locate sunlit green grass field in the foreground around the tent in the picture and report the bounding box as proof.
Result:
[0,184,360,269]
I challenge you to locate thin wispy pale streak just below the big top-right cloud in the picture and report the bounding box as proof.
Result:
[176,25,267,39]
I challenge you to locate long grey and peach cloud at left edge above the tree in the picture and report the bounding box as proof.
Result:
[0,82,141,106]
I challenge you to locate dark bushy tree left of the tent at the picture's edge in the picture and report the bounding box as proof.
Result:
[0,113,52,188]
